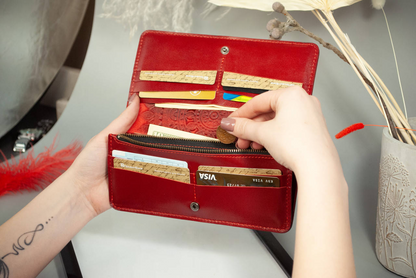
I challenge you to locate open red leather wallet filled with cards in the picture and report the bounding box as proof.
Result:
[108,31,319,233]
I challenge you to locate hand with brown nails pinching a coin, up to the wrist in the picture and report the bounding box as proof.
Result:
[221,86,339,173]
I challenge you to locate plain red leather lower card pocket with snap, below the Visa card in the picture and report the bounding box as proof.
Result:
[108,166,291,232]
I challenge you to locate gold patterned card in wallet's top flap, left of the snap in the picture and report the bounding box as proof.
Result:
[139,70,217,85]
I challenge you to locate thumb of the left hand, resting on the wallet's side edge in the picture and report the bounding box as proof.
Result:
[102,95,140,135]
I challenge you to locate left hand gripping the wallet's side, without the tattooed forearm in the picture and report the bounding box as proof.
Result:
[65,95,139,216]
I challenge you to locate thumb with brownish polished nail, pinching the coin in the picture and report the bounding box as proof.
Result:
[221,118,263,144]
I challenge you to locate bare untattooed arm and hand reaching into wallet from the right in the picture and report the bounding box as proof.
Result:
[221,87,355,277]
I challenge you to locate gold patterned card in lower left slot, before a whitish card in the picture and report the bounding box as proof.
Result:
[113,157,191,183]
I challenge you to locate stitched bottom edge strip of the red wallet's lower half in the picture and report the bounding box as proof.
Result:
[113,204,287,232]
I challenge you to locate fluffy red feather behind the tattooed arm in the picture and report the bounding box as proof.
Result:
[0,138,82,196]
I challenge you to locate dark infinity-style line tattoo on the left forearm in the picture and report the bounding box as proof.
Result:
[0,216,53,278]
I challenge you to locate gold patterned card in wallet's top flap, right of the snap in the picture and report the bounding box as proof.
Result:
[221,71,302,90]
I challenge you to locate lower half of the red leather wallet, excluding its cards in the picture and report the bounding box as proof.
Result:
[108,135,292,233]
